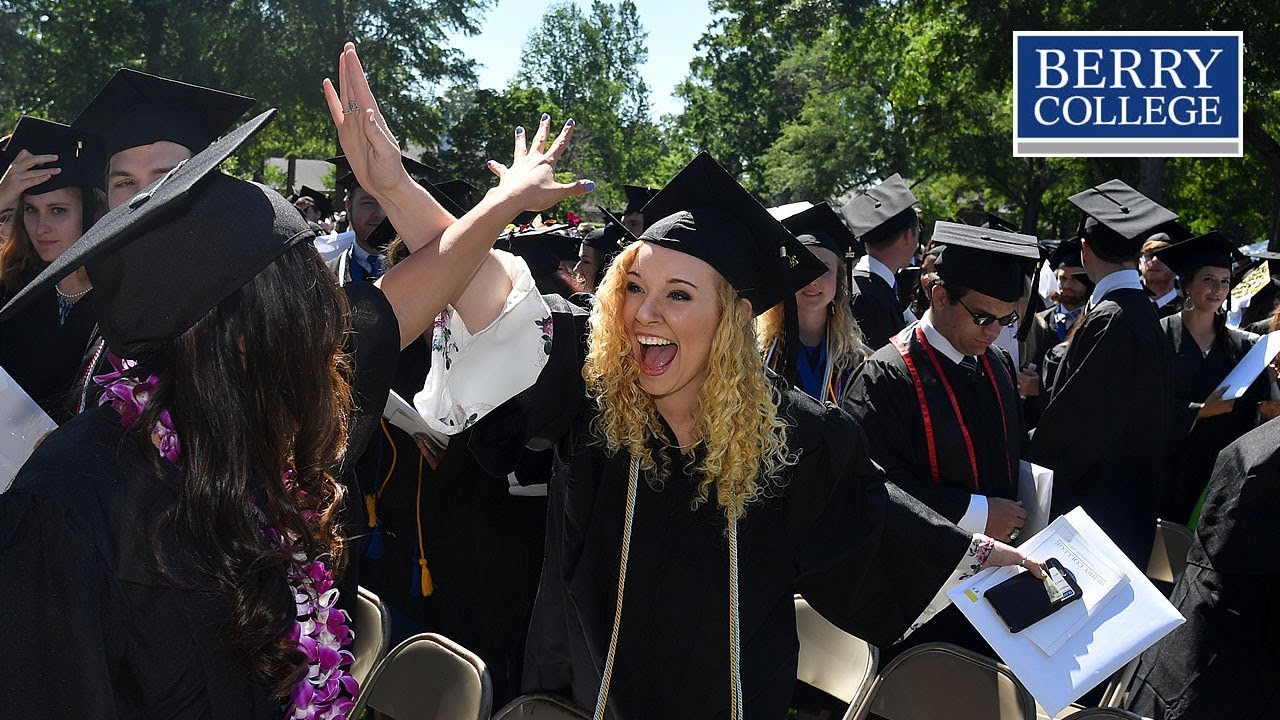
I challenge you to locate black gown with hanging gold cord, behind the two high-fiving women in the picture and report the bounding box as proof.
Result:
[356,338,549,706]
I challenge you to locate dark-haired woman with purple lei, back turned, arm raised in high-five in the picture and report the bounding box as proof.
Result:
[0,45,589,719]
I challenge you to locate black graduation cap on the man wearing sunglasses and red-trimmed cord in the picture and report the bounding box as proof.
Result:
[933,220,1041,302]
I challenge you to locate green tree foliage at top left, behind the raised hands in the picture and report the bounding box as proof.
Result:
[0,0,489,177]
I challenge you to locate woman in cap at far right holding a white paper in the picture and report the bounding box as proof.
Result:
[1155,232,1270,527]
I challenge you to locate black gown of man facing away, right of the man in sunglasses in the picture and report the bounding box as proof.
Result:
[1032,284,1174,568]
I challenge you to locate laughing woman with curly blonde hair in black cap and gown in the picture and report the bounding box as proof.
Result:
[416,152,1030,719]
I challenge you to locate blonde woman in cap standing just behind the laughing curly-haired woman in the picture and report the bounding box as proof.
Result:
[756,202,872,405]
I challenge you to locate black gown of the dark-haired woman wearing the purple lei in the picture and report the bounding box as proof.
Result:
[0,279,399,720]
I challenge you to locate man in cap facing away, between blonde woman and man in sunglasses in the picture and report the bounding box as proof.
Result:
[841,173,920,348]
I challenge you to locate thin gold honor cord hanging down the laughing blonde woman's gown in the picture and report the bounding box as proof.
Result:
[591,457,744,720]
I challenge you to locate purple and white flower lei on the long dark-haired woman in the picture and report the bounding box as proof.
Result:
[93,352,360,720]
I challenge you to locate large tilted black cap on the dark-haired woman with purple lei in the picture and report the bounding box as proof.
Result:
[0,110,299,357]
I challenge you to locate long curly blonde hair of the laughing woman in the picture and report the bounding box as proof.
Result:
[582,242,795,518]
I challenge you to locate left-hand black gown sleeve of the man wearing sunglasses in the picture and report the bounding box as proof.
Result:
[844,357,972,523]
